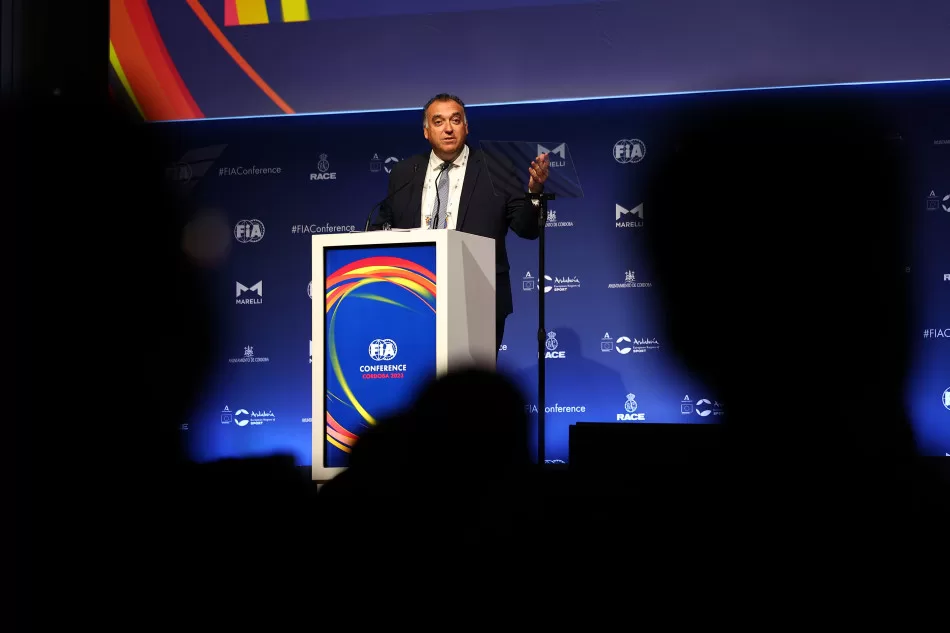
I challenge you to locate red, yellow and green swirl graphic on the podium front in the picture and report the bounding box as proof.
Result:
[326,256,436,453]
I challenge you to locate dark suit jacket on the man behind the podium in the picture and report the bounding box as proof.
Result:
[379,146,541,318]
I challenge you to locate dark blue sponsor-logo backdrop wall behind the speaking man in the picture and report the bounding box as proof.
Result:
[155,84,950,464]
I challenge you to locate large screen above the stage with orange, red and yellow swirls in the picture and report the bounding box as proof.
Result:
[111,0,950,120]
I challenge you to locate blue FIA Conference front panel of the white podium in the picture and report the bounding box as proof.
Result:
[323,243,436,468]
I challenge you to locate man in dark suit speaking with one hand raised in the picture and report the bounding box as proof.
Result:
[380,94,549,347]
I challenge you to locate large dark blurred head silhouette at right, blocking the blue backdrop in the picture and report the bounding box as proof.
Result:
[646,93,909,455]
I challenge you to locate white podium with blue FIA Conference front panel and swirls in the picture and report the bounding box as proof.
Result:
[311,229,497,481]
